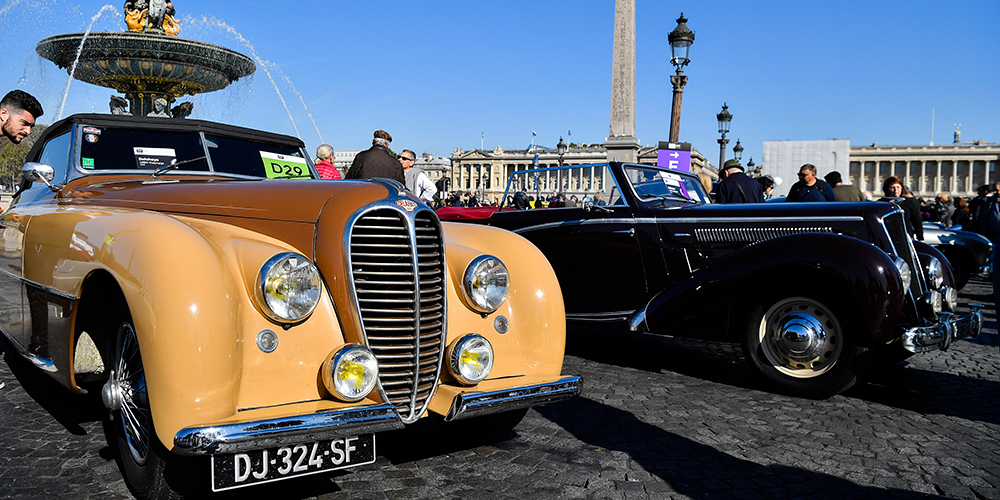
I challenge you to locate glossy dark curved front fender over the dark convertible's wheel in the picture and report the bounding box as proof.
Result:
[634,233,904,342]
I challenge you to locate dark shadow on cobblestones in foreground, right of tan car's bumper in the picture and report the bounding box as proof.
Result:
[537,397,945,499]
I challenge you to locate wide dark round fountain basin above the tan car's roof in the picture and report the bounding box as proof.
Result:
[35,32,257,115]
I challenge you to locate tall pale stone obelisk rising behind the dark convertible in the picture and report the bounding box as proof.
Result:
[604,0,639,162]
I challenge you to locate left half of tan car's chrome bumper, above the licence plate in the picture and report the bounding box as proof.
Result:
[173,404,404,455]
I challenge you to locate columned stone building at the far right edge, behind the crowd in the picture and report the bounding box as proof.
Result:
[844,137,1000,197]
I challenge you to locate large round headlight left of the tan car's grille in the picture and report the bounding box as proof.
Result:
[257,252,322,323]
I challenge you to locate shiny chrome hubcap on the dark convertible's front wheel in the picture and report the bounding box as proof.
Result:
[759,297,842,378]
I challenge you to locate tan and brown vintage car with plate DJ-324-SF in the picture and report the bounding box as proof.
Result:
[0,114,580,498]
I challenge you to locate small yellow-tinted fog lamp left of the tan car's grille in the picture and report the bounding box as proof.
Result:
[323,344,378,402]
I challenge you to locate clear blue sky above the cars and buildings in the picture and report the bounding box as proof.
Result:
[0,0,1000,171]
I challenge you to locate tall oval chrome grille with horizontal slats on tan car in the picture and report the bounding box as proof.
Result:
[350,209,446,423]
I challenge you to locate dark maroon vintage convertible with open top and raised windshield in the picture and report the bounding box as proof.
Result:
[438,162,982,397]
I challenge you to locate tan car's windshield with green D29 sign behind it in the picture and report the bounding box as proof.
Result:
[79,127,313,179]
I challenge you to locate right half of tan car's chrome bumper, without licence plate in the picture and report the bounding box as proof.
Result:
[444,377,582,422]
